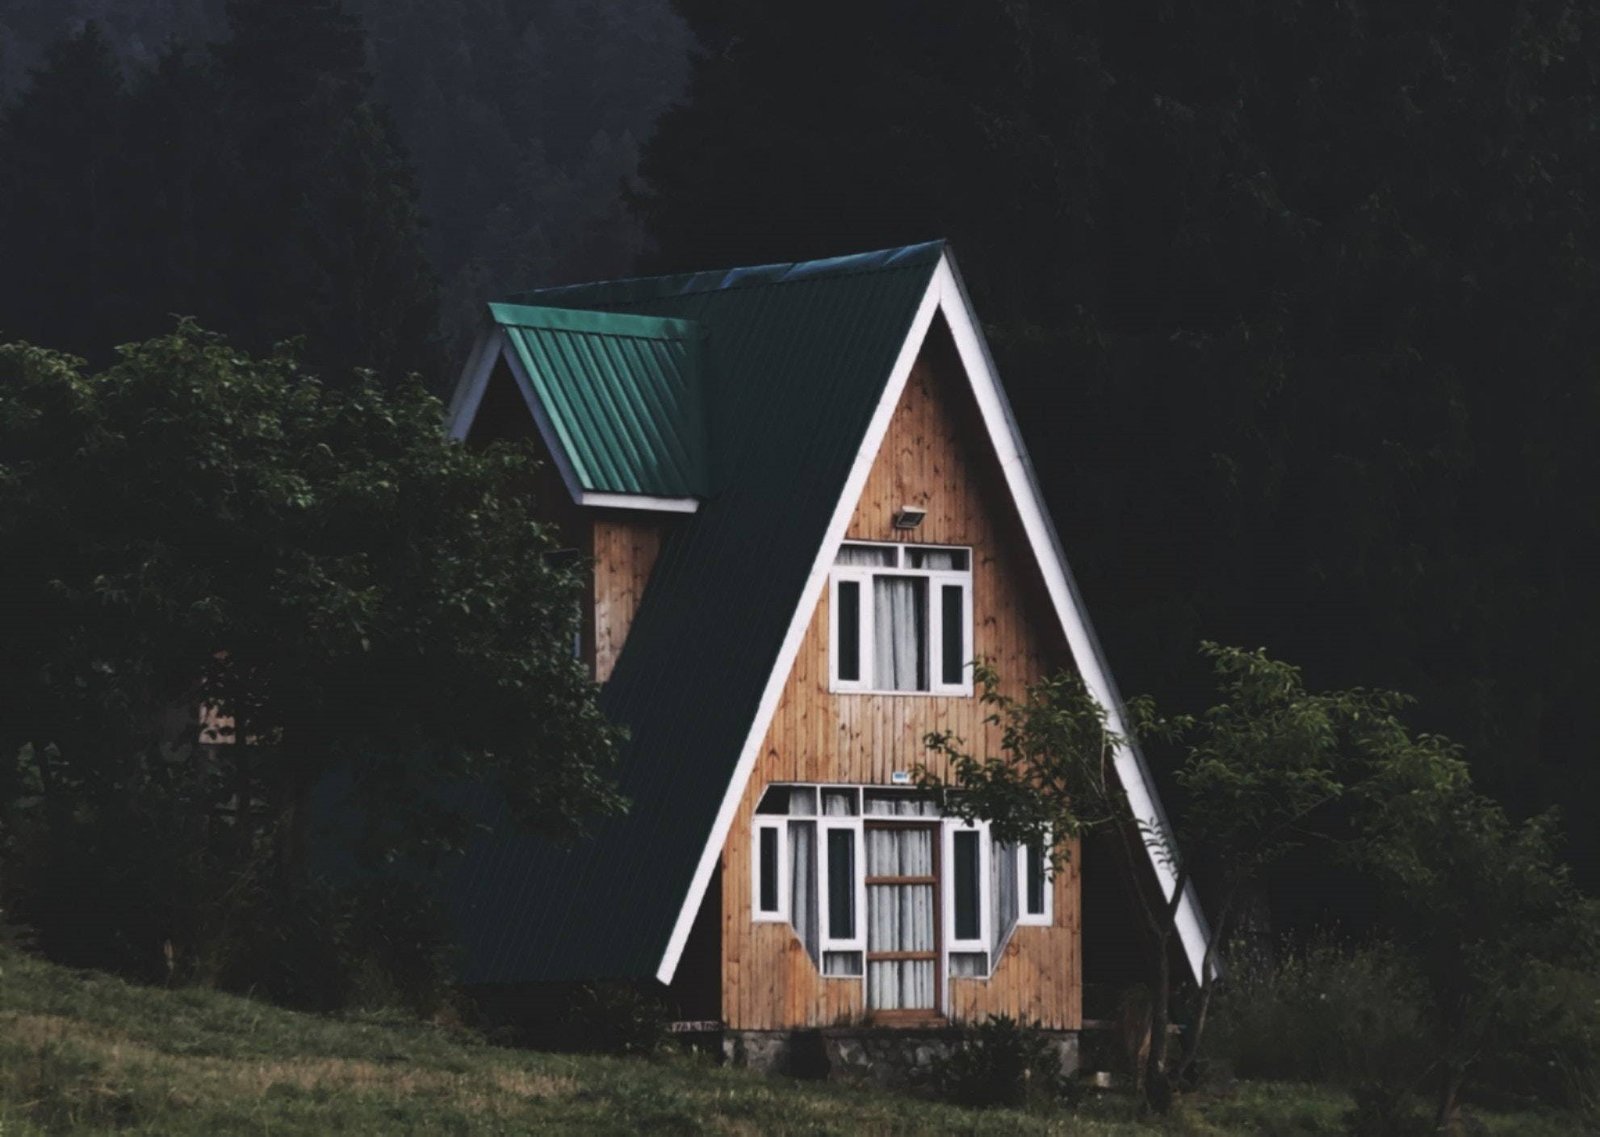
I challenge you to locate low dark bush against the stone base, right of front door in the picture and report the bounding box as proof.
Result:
[930,1015,1072,1110]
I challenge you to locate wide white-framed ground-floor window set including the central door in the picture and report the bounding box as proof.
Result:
[750,785,1054,1017]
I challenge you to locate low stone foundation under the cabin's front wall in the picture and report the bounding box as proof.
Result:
[722,1027,1078,1087]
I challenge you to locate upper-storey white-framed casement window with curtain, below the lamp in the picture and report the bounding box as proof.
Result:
[829,541,973,696]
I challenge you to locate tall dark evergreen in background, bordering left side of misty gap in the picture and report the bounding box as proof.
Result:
[218,0,438,385]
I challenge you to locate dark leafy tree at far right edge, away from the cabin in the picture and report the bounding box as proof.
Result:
[1352,732,1600,1132]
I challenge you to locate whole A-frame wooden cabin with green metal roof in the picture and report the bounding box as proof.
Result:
[438,241,1205,1062]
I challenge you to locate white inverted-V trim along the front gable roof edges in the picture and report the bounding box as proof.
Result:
[656,251,1208,983]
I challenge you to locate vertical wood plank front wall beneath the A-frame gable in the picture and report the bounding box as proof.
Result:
[722,341,1082,1030]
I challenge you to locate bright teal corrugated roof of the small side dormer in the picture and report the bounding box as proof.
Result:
[490,304,710,497]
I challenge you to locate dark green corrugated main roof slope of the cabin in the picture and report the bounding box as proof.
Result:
[453,241,944,982]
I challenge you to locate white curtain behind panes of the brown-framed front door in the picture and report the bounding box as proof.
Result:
[867,828,934,1011]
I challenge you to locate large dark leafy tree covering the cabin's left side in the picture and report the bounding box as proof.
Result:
[0,323,621,982]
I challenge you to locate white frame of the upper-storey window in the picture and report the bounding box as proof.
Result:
[827,541,974,696]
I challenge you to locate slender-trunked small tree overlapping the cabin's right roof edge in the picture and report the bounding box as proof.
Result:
[922,644,1403,1111]
